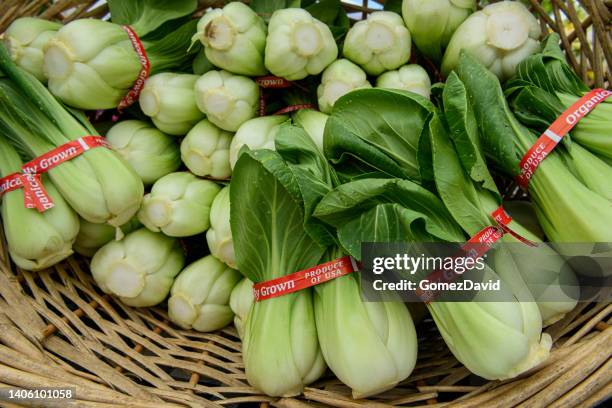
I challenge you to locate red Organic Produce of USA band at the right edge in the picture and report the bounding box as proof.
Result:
[517,89,612,188]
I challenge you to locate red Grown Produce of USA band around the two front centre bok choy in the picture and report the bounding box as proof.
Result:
[253,256,358,302]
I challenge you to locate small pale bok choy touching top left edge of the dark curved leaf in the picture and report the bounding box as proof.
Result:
[317,59,372,113]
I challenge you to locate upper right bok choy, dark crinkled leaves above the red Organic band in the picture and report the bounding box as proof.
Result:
[505,34,612,165]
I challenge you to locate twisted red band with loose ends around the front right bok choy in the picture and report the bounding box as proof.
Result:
[416,205,536,303]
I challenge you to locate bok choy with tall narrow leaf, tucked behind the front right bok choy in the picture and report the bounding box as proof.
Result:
[438,73,579,325]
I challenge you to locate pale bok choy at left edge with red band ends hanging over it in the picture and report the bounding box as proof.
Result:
[0,136,79,271]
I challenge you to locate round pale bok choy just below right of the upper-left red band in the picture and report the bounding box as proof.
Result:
[139,72,204,136]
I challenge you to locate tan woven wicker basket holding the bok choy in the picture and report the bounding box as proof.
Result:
[0,0,612,408]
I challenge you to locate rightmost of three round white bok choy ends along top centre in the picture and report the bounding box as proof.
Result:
[342,11,411,75]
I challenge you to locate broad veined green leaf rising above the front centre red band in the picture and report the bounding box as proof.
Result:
[230,150,324,282]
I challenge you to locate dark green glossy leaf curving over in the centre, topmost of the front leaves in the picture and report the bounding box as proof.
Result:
[324,89,434,183]
